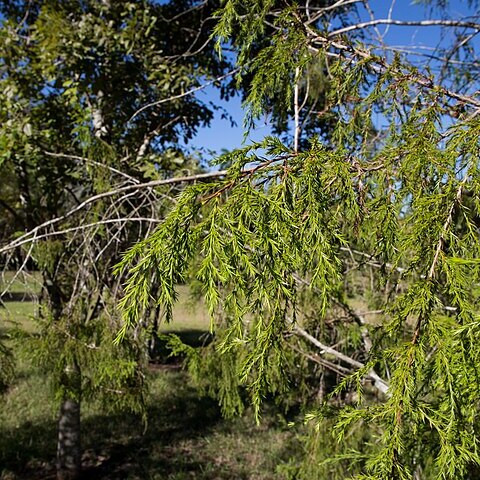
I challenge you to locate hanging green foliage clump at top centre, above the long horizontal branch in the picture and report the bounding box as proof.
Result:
[213,0,351,138]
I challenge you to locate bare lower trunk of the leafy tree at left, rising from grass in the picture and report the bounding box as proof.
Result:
[57,368,82,480]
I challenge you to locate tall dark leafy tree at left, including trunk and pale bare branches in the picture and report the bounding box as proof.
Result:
[0,0,232,478]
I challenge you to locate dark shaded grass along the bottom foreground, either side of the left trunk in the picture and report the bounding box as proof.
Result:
[0,358,300,480]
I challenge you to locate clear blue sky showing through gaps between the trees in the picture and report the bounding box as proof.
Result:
[190,0,478,157]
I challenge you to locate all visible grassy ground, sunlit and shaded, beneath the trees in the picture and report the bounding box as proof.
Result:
[0,285,299,480]
